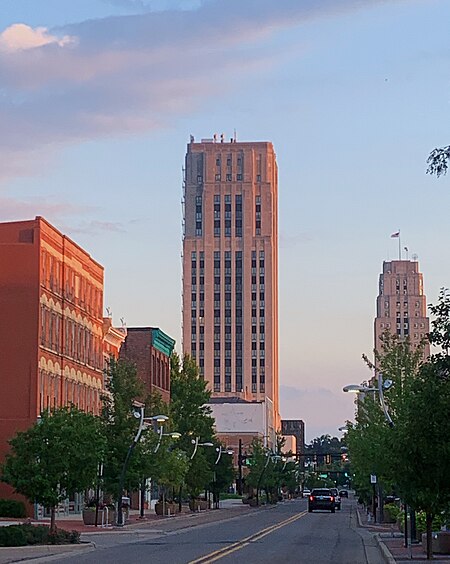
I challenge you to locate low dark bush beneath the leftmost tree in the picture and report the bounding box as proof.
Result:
[0,524,80,546]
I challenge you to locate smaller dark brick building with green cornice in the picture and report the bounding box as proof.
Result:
[119,327,175,403]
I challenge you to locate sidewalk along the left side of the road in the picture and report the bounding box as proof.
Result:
[0,500,253,564]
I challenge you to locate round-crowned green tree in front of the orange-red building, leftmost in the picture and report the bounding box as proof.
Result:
[2,407,106,533]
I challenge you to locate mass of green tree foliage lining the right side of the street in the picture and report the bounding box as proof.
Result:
[346,290,450,558]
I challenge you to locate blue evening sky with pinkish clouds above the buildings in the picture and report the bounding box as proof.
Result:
[0,0,450,441]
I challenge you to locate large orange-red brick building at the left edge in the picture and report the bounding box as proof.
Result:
[0,217,104,504]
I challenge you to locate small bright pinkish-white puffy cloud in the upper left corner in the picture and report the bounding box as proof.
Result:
[0,23,74,52]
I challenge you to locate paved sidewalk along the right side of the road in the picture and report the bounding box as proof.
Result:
[356,504,450,564]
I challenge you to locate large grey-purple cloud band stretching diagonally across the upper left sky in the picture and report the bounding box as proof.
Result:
[0,0,406,180]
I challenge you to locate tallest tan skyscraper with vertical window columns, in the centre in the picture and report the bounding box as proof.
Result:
[183,136,279,421]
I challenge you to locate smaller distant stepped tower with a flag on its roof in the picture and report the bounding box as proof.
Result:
[375,260,430,357]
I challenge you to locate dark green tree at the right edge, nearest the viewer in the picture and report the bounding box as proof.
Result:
[391,289,450,559]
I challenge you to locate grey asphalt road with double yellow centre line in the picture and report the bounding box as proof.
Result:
[52,500,384,564]
